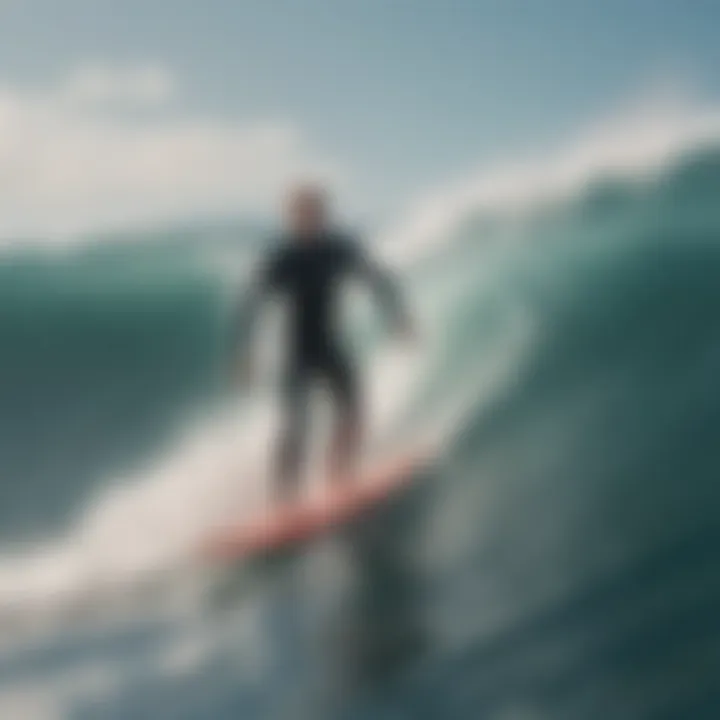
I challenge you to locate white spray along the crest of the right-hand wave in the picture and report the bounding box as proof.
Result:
[381,97,720,260]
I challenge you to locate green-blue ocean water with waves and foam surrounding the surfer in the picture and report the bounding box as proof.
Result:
[0,121,720,720]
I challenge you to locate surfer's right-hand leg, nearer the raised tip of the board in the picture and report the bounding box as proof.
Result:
[324,353,362,481]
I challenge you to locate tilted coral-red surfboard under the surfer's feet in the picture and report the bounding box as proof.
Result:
[201,452,426,562]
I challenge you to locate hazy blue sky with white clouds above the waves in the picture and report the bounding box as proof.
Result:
[0,0,720,234]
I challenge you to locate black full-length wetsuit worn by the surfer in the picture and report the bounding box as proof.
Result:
[250,232,404,496]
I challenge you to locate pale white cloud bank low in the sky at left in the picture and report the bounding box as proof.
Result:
[0,65,337,241]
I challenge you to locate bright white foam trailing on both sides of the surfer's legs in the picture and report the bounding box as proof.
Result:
[0,338,419,629]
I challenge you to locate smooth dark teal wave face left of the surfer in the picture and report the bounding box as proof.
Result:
[0,236,228,540]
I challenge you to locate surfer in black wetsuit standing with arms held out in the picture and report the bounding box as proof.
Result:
[243,185,413,503]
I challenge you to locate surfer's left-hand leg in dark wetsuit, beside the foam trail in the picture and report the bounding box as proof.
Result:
[275,367,309,503]
